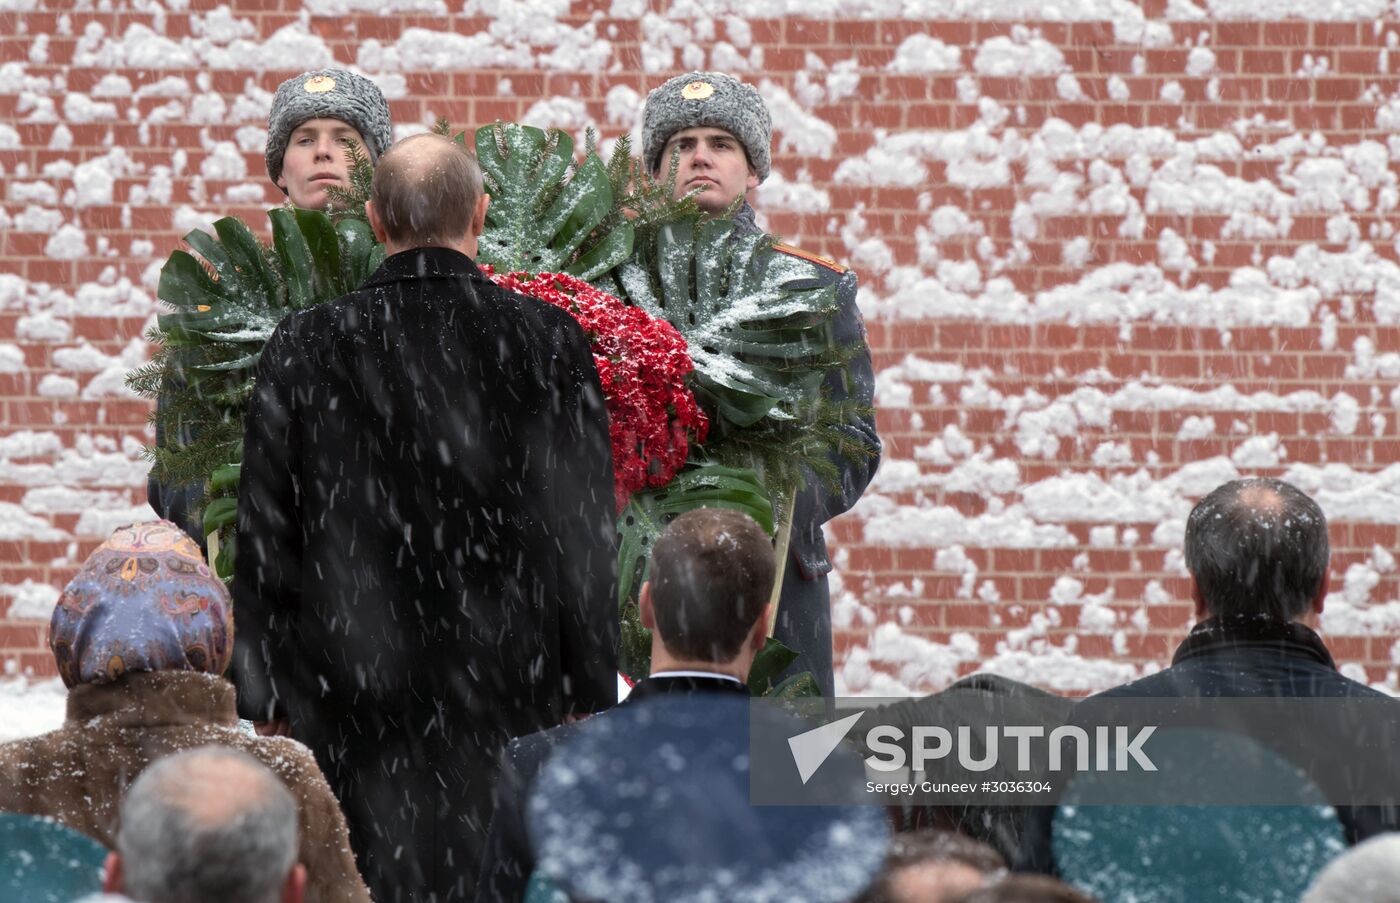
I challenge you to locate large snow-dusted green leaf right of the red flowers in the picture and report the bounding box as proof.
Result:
[609,216,871,515]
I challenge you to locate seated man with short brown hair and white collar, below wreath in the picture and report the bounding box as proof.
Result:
[476,508,776,903]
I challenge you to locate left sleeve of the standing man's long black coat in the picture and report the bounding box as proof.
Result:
[234,321,304,721]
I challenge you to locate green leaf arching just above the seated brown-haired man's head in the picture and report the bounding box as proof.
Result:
[617,462,774,679]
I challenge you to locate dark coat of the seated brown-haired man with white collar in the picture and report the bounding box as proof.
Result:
[476,676,749,903]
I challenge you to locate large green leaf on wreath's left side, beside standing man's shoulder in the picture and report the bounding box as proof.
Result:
[127,207,384,520]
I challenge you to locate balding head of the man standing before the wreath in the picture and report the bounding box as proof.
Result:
[364,134,491,258]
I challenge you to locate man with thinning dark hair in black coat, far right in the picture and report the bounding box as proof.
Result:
[1019,479,1400,875]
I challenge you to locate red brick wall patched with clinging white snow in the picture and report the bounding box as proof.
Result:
[0,0,1400,694]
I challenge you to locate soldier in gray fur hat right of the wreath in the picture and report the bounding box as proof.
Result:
[641,71,881,696]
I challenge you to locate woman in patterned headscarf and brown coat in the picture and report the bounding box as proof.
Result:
[0,521,370,903]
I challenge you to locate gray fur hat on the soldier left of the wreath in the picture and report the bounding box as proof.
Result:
[263,69,393,185]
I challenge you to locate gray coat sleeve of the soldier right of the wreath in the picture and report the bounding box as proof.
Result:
[791,265,881,578]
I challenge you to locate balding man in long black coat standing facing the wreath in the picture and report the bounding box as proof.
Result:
[234,134,617,903]
